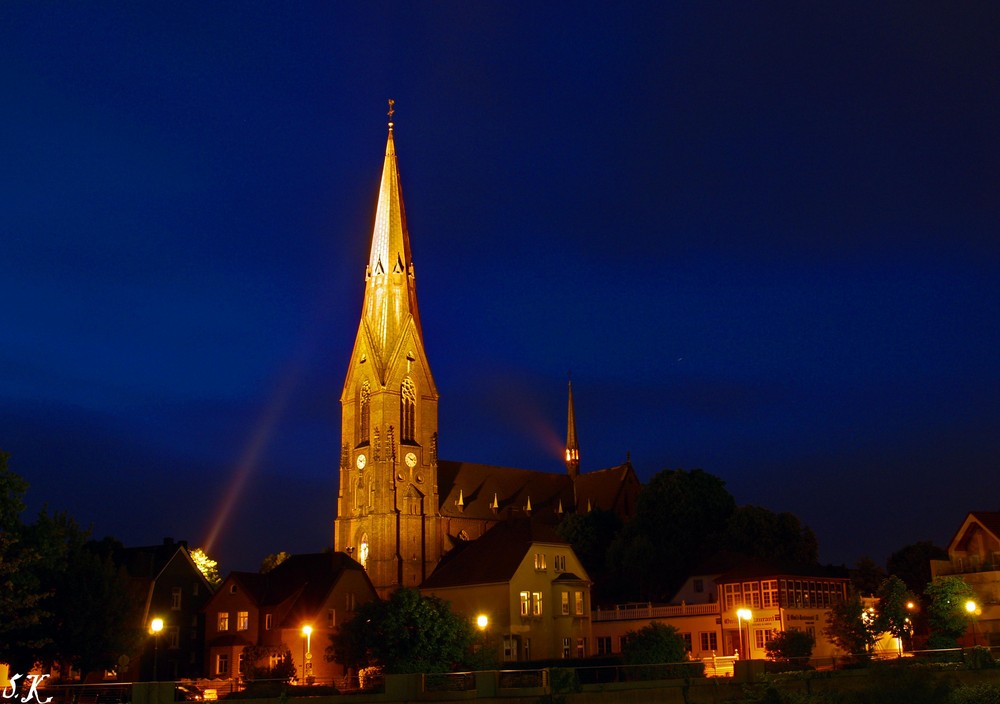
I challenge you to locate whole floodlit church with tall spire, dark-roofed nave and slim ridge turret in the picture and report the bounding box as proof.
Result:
[334,108,641,597]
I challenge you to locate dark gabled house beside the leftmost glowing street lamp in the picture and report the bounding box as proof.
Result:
[114,538,212,681]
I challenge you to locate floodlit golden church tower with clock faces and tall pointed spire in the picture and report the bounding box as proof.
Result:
[334,107,441,597]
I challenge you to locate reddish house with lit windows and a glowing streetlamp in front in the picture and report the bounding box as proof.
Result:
[204,552,377,682]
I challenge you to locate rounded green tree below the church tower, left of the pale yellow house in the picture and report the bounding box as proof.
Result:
[326,589,474,674]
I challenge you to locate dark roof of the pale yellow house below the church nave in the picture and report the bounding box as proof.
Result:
[420,518,569,589]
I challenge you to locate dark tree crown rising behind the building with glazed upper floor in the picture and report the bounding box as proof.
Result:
[719,505,819,565]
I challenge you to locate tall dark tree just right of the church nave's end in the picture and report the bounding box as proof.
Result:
[609,469,736,599]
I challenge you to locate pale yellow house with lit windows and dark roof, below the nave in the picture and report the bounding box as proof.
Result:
[420,518,593,662]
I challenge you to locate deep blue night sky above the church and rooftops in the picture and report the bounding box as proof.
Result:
[0,0,1000,573]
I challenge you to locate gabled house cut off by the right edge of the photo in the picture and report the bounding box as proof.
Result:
[931,511,1000,645]
